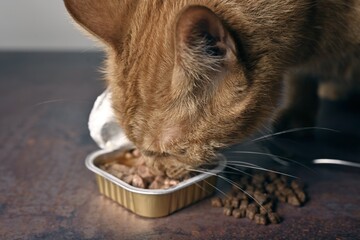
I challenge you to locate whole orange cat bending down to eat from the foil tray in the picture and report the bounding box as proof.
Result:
[65,0,360,178]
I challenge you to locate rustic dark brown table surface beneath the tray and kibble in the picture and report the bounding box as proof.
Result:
[0,52,360,239]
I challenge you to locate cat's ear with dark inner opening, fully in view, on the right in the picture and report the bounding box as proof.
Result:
[175,6,236,78]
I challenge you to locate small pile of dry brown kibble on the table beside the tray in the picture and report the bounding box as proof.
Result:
[211,173,306,225]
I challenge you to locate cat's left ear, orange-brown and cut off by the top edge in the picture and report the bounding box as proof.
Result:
[64,0,126,45]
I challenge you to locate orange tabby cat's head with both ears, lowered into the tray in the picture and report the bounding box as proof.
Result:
[65,0,296,175]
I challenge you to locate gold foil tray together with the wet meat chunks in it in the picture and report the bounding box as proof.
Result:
[85,147,225,218]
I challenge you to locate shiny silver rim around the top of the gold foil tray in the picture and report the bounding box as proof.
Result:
[85,147,227,195]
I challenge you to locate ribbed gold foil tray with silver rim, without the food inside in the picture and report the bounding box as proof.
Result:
[86,149,226,218]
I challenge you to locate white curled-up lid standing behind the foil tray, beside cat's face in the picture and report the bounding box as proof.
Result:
[89,89,134,150]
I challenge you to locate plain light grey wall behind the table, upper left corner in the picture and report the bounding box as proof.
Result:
[0,0,100,51]
